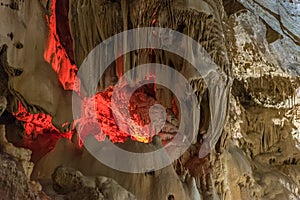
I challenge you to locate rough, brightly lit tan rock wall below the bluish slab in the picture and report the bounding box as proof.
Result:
[209,11,300,199]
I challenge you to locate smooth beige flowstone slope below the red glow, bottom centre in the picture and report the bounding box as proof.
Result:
[33,139,200,200]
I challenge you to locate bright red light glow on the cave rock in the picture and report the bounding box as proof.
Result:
[14,0,169,158]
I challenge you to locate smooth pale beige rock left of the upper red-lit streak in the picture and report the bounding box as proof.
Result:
[0,0,73,131]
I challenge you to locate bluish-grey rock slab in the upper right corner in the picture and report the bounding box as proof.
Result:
[239,0,300,75]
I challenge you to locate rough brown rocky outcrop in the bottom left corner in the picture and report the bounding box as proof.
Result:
[0,125,48,200]
